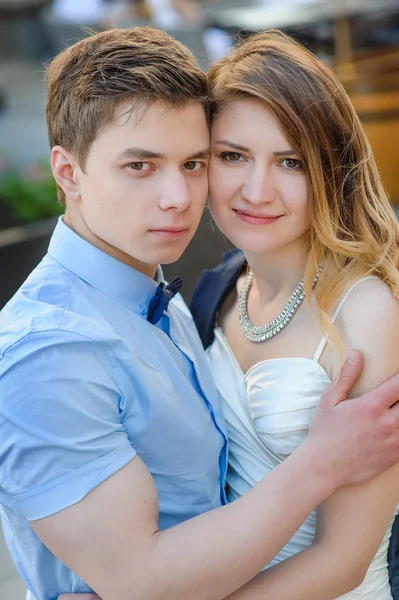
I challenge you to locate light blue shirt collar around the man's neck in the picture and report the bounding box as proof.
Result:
[48,217,163,317]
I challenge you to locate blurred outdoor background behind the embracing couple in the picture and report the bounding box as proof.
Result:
[0,0,399,600]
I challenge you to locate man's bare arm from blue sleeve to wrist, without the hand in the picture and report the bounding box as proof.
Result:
[37,449,331,600]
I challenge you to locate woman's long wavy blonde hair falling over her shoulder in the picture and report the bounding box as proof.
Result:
[208,31,399,348]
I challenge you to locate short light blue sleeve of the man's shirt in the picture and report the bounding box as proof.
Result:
[0,331,136,521]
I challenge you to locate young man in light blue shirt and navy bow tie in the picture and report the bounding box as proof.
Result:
[0,29,399,600]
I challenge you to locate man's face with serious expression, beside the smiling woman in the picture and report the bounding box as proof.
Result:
[65,102,209,275]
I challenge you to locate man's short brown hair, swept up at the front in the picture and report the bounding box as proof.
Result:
[46,27,208,203]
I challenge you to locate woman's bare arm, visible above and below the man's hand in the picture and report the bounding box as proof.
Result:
[222,280,399,600]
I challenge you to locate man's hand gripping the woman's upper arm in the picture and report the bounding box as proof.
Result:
[305,351,399,487]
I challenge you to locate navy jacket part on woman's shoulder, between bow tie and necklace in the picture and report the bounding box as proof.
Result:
[190,249,246,348]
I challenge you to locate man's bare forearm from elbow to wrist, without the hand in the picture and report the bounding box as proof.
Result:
[126,444,333,600]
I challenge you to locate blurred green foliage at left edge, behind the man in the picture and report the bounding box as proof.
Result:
[0,160,63,223]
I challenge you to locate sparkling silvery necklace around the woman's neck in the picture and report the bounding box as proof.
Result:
[238,259,324,343]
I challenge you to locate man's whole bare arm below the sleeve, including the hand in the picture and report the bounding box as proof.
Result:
[37,354,399,600]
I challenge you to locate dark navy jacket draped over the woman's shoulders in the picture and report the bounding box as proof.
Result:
[190,250,399,600]
